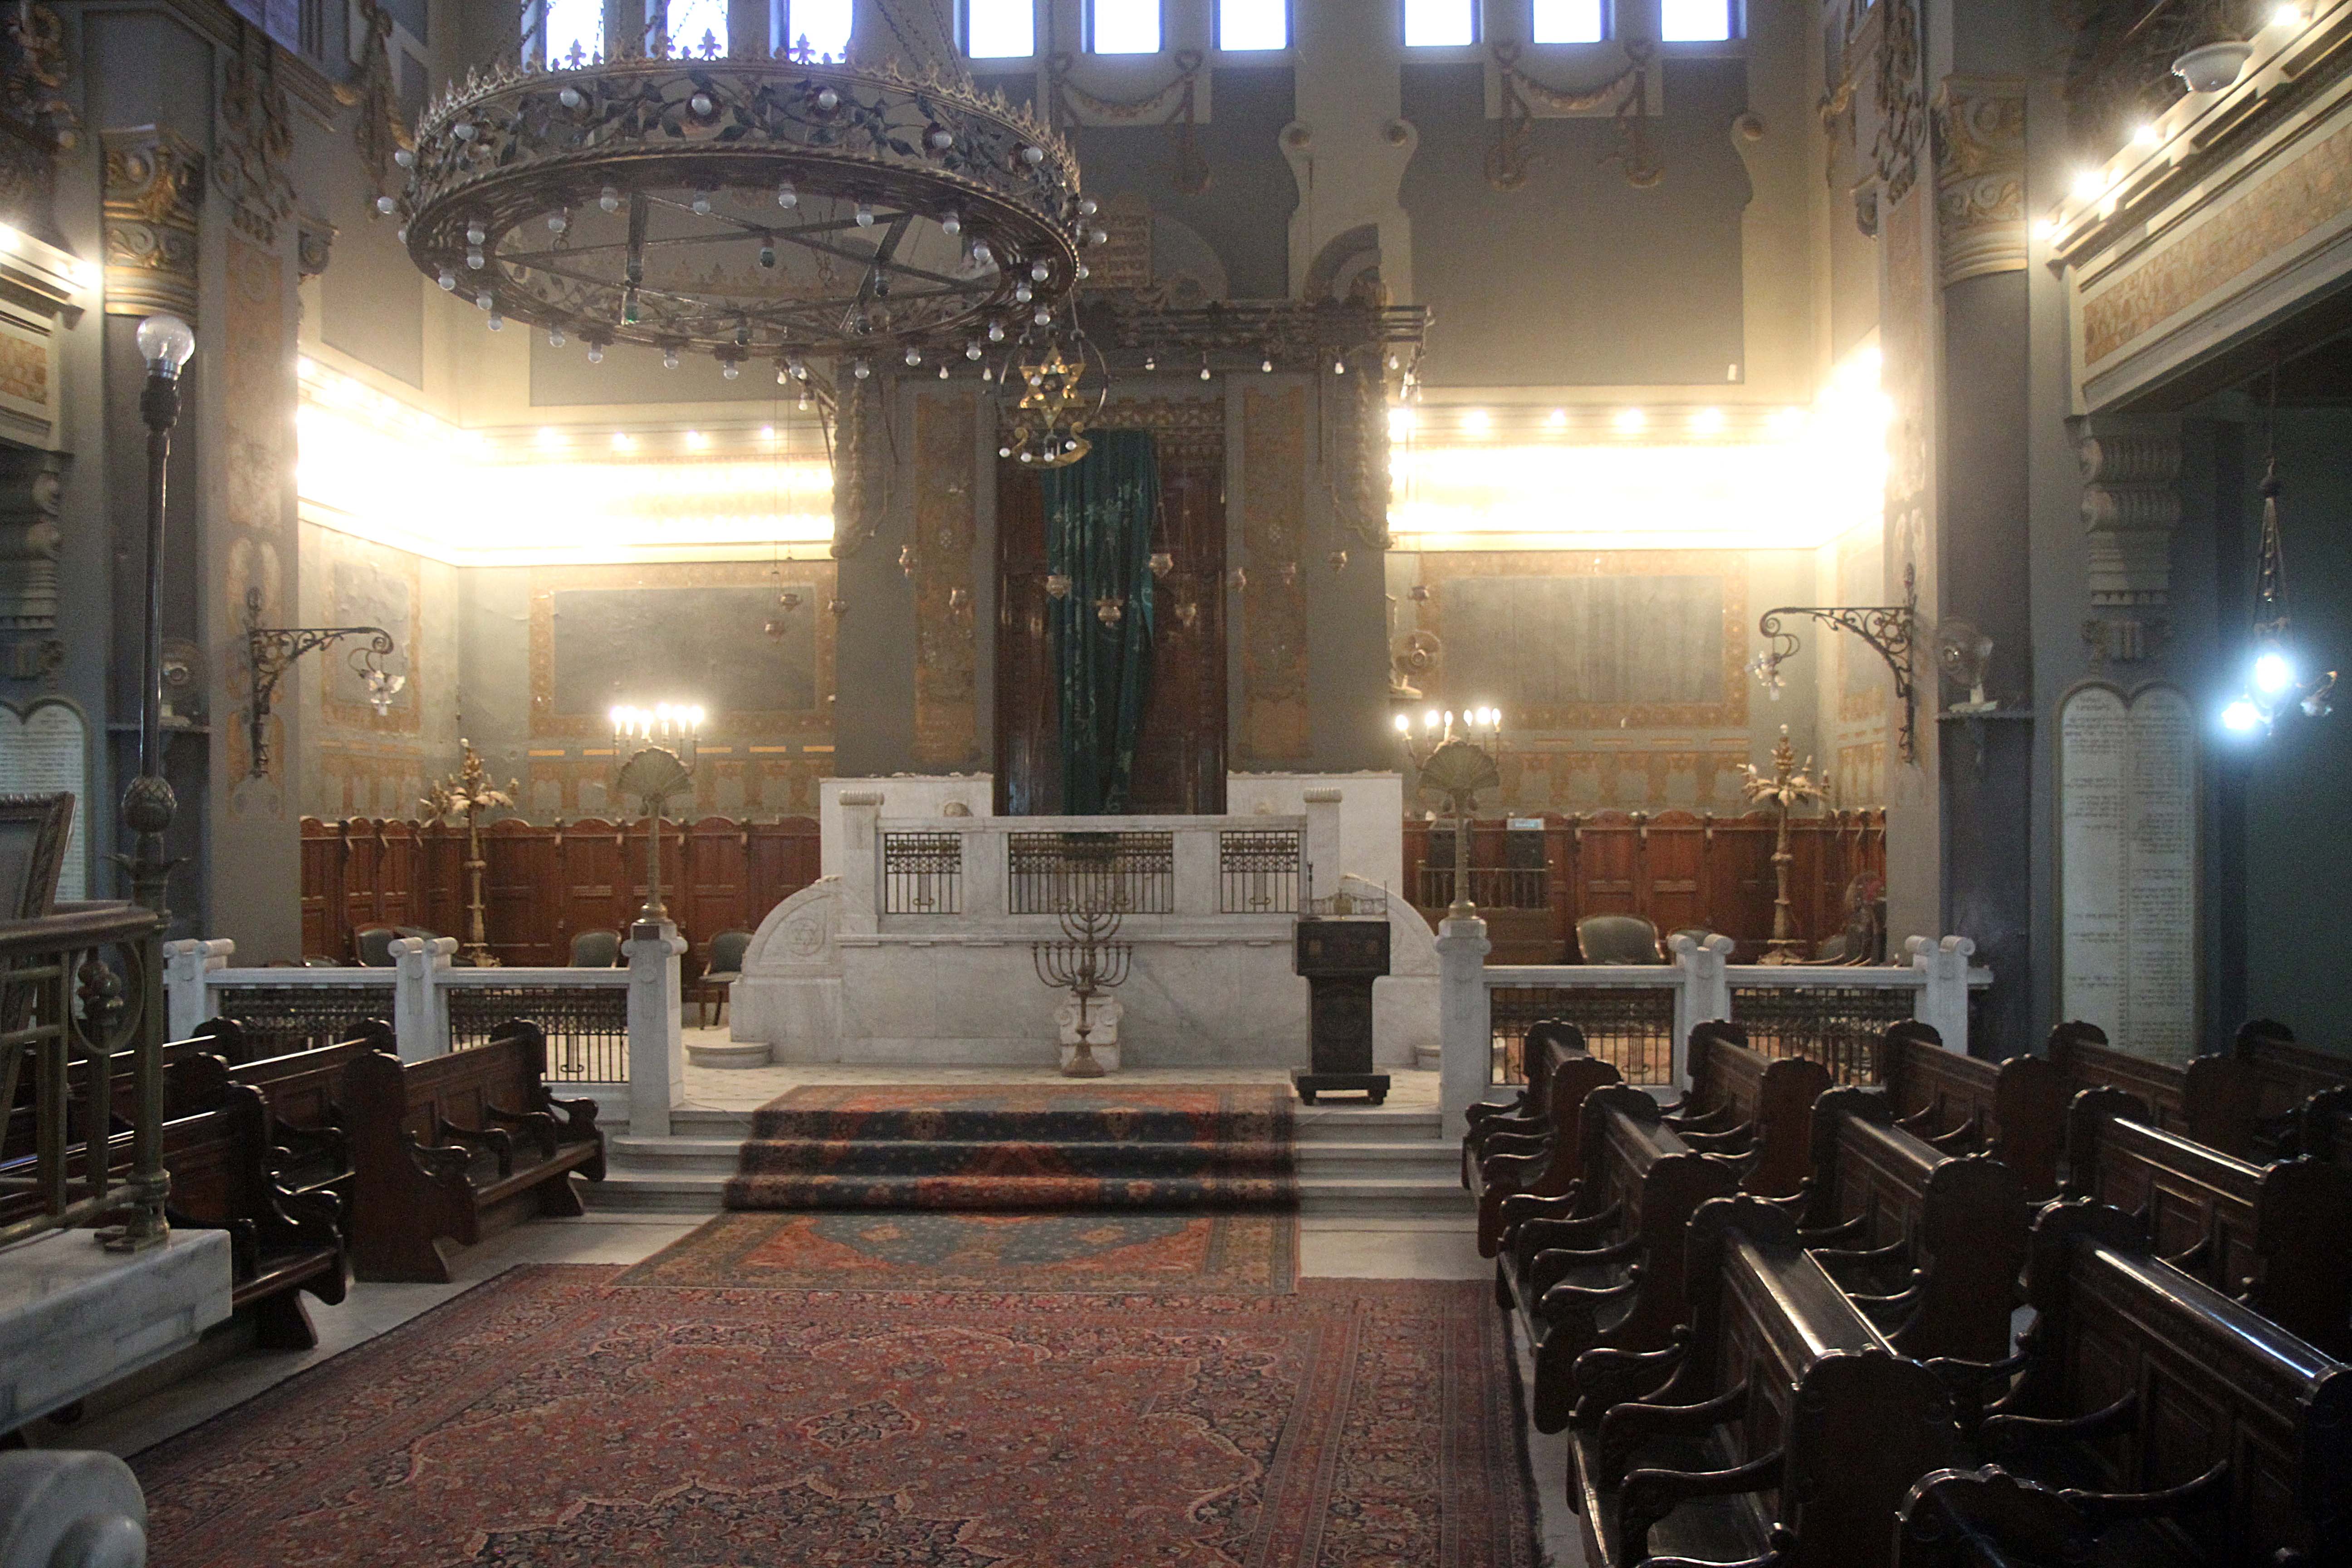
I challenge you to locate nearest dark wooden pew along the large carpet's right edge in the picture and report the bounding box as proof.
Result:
[1686,1196,1959,1568]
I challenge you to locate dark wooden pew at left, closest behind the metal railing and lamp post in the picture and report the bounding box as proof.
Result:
[0,1079,350,1349]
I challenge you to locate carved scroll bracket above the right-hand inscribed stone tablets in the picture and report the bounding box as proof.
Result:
[2068,414,2180,663]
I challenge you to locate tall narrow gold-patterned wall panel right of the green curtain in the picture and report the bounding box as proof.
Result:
[1240,386,1315,764]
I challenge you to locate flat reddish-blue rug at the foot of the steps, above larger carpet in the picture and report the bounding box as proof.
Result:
[618,1208,1298,1295]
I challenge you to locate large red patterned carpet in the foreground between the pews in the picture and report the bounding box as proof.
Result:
[132,1265,1536,1568]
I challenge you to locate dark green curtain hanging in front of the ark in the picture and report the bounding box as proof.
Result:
[1037,430,1160,816]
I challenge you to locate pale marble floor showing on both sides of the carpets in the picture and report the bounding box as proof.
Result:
[28,1213,1585,1568]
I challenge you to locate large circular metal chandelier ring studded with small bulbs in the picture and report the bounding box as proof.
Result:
[381,52,1103,381]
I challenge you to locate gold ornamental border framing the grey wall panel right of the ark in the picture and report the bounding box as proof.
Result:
[1421,550,1748,733]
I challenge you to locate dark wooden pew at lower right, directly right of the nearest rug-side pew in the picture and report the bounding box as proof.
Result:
[1987,1201,2352,1568]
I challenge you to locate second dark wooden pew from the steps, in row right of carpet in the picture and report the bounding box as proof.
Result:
[1496,1084,1738,1431]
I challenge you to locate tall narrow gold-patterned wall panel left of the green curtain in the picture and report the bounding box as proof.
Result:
[903,388,981,769]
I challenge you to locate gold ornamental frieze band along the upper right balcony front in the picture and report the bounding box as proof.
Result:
[2082,125,2352,364]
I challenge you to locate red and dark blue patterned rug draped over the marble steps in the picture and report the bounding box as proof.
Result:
[727,1084,1298,1210]
